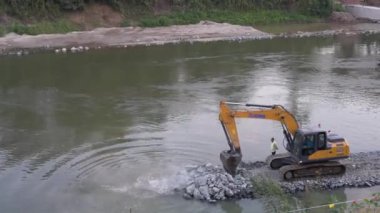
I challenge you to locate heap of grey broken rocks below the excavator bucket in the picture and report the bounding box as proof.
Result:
[183,164,253,203]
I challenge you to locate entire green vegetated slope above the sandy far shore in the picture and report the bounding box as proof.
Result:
[0,0,334,36]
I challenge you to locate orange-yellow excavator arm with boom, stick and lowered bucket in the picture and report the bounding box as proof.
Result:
[219,101,299,174]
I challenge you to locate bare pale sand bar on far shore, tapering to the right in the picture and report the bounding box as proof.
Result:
[0,21,271,54]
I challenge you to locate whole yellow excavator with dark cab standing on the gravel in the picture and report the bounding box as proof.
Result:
[219,101,350,180]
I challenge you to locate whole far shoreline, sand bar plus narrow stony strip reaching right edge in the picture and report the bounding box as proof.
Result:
[0,21,380,56]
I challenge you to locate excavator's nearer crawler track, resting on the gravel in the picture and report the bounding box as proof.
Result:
[279,161,346,180]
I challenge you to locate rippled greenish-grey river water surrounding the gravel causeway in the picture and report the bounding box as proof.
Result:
[0,32,380,213]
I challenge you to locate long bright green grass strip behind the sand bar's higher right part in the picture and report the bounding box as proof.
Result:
[134,9,319,27]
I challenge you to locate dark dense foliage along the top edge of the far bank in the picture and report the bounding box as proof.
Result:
[0,0,332,18]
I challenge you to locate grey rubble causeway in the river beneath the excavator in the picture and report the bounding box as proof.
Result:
[177,151,380,203]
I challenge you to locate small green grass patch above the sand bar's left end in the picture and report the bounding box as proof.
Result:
[4,19,78,35]
